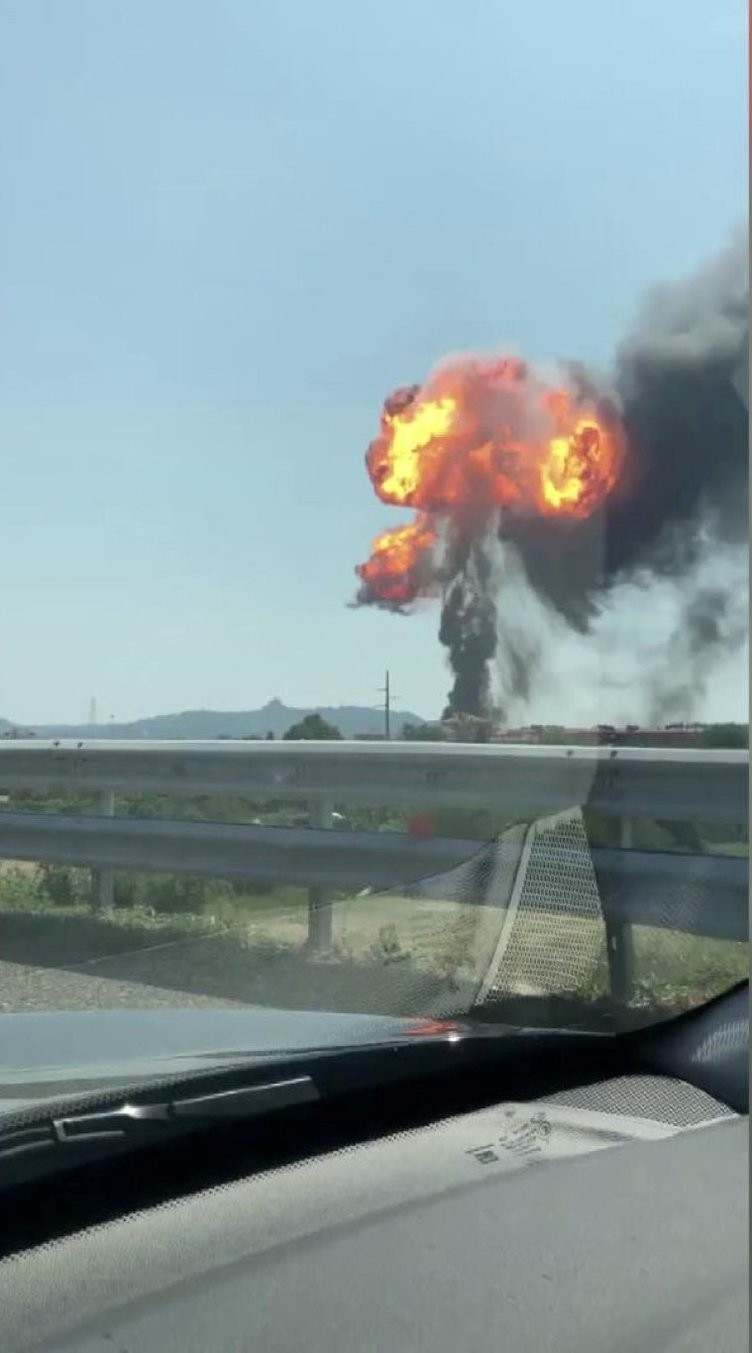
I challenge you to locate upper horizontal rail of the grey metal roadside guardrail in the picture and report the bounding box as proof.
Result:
[0,740,748,821]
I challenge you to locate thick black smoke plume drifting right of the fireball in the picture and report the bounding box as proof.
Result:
[500,241,749,630]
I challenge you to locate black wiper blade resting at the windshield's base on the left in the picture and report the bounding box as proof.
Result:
[0,1076,321,1160]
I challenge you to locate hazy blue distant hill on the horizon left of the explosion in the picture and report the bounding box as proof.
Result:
[0,700,423,741]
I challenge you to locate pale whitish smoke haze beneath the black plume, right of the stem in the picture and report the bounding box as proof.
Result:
[498,544,749,727]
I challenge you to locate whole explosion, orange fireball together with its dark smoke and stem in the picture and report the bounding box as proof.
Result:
[357,239,748,714]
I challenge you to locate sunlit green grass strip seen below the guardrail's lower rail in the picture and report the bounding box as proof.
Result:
[0,865,748,1013]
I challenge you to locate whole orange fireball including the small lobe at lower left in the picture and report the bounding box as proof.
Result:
[357,357,625,605]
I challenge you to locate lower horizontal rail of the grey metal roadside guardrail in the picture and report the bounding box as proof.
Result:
[0,813,747,939]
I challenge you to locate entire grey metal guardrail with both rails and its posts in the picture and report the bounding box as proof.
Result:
[0,740,748,1006]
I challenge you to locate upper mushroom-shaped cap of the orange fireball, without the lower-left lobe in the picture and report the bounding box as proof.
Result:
[367,359,622,517]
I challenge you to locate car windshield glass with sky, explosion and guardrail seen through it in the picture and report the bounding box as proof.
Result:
[0,0,748,1057]
